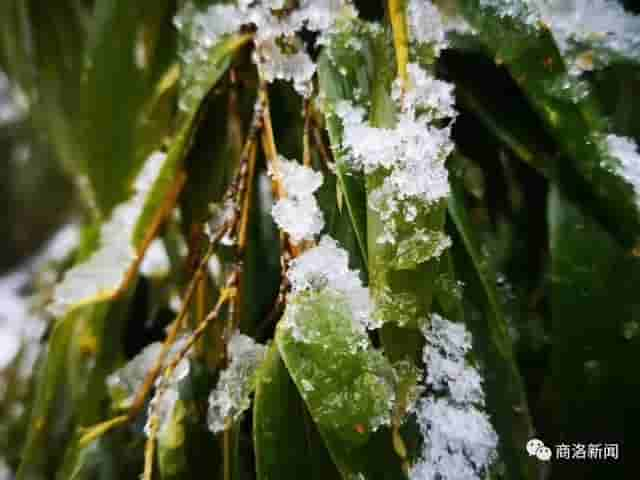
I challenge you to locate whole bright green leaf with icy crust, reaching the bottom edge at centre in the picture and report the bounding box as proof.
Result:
[276,291,404,479]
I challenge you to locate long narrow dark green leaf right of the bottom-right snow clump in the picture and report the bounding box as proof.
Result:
[449,157,538,479]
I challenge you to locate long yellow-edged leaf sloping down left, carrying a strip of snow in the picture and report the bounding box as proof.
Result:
[51,30,246,315]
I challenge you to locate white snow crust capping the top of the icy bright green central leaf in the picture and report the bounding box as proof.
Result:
[287,235,380,329]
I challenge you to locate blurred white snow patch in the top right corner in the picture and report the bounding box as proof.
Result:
[536,0,640,73]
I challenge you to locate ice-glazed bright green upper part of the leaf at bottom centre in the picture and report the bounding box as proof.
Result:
[276,289,395,442]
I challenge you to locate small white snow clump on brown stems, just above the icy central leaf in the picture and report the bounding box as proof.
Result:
[271,157,324,243]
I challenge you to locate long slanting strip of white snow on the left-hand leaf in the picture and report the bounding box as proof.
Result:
[49,152,166,316]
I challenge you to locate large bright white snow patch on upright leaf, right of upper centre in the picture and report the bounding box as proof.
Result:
[335,64,455,216]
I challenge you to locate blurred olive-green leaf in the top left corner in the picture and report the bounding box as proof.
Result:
[0,0,87,188]
